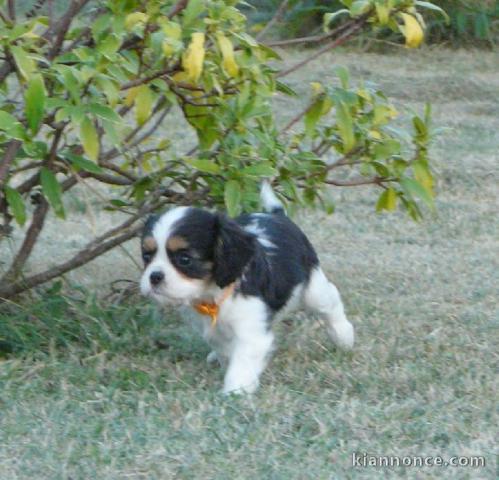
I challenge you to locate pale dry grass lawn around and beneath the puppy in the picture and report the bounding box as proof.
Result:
[0,50,499,479]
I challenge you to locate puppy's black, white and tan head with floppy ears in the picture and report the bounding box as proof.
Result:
[140,207,256,304]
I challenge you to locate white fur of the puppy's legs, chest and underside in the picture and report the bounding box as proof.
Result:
[181,267,354,394]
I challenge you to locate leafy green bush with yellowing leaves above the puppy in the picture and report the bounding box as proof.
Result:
[0,0,433,298]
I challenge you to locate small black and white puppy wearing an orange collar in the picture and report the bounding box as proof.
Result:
[140,183,354,393]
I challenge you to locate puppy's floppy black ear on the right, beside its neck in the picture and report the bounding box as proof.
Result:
[213,214,255,288]
